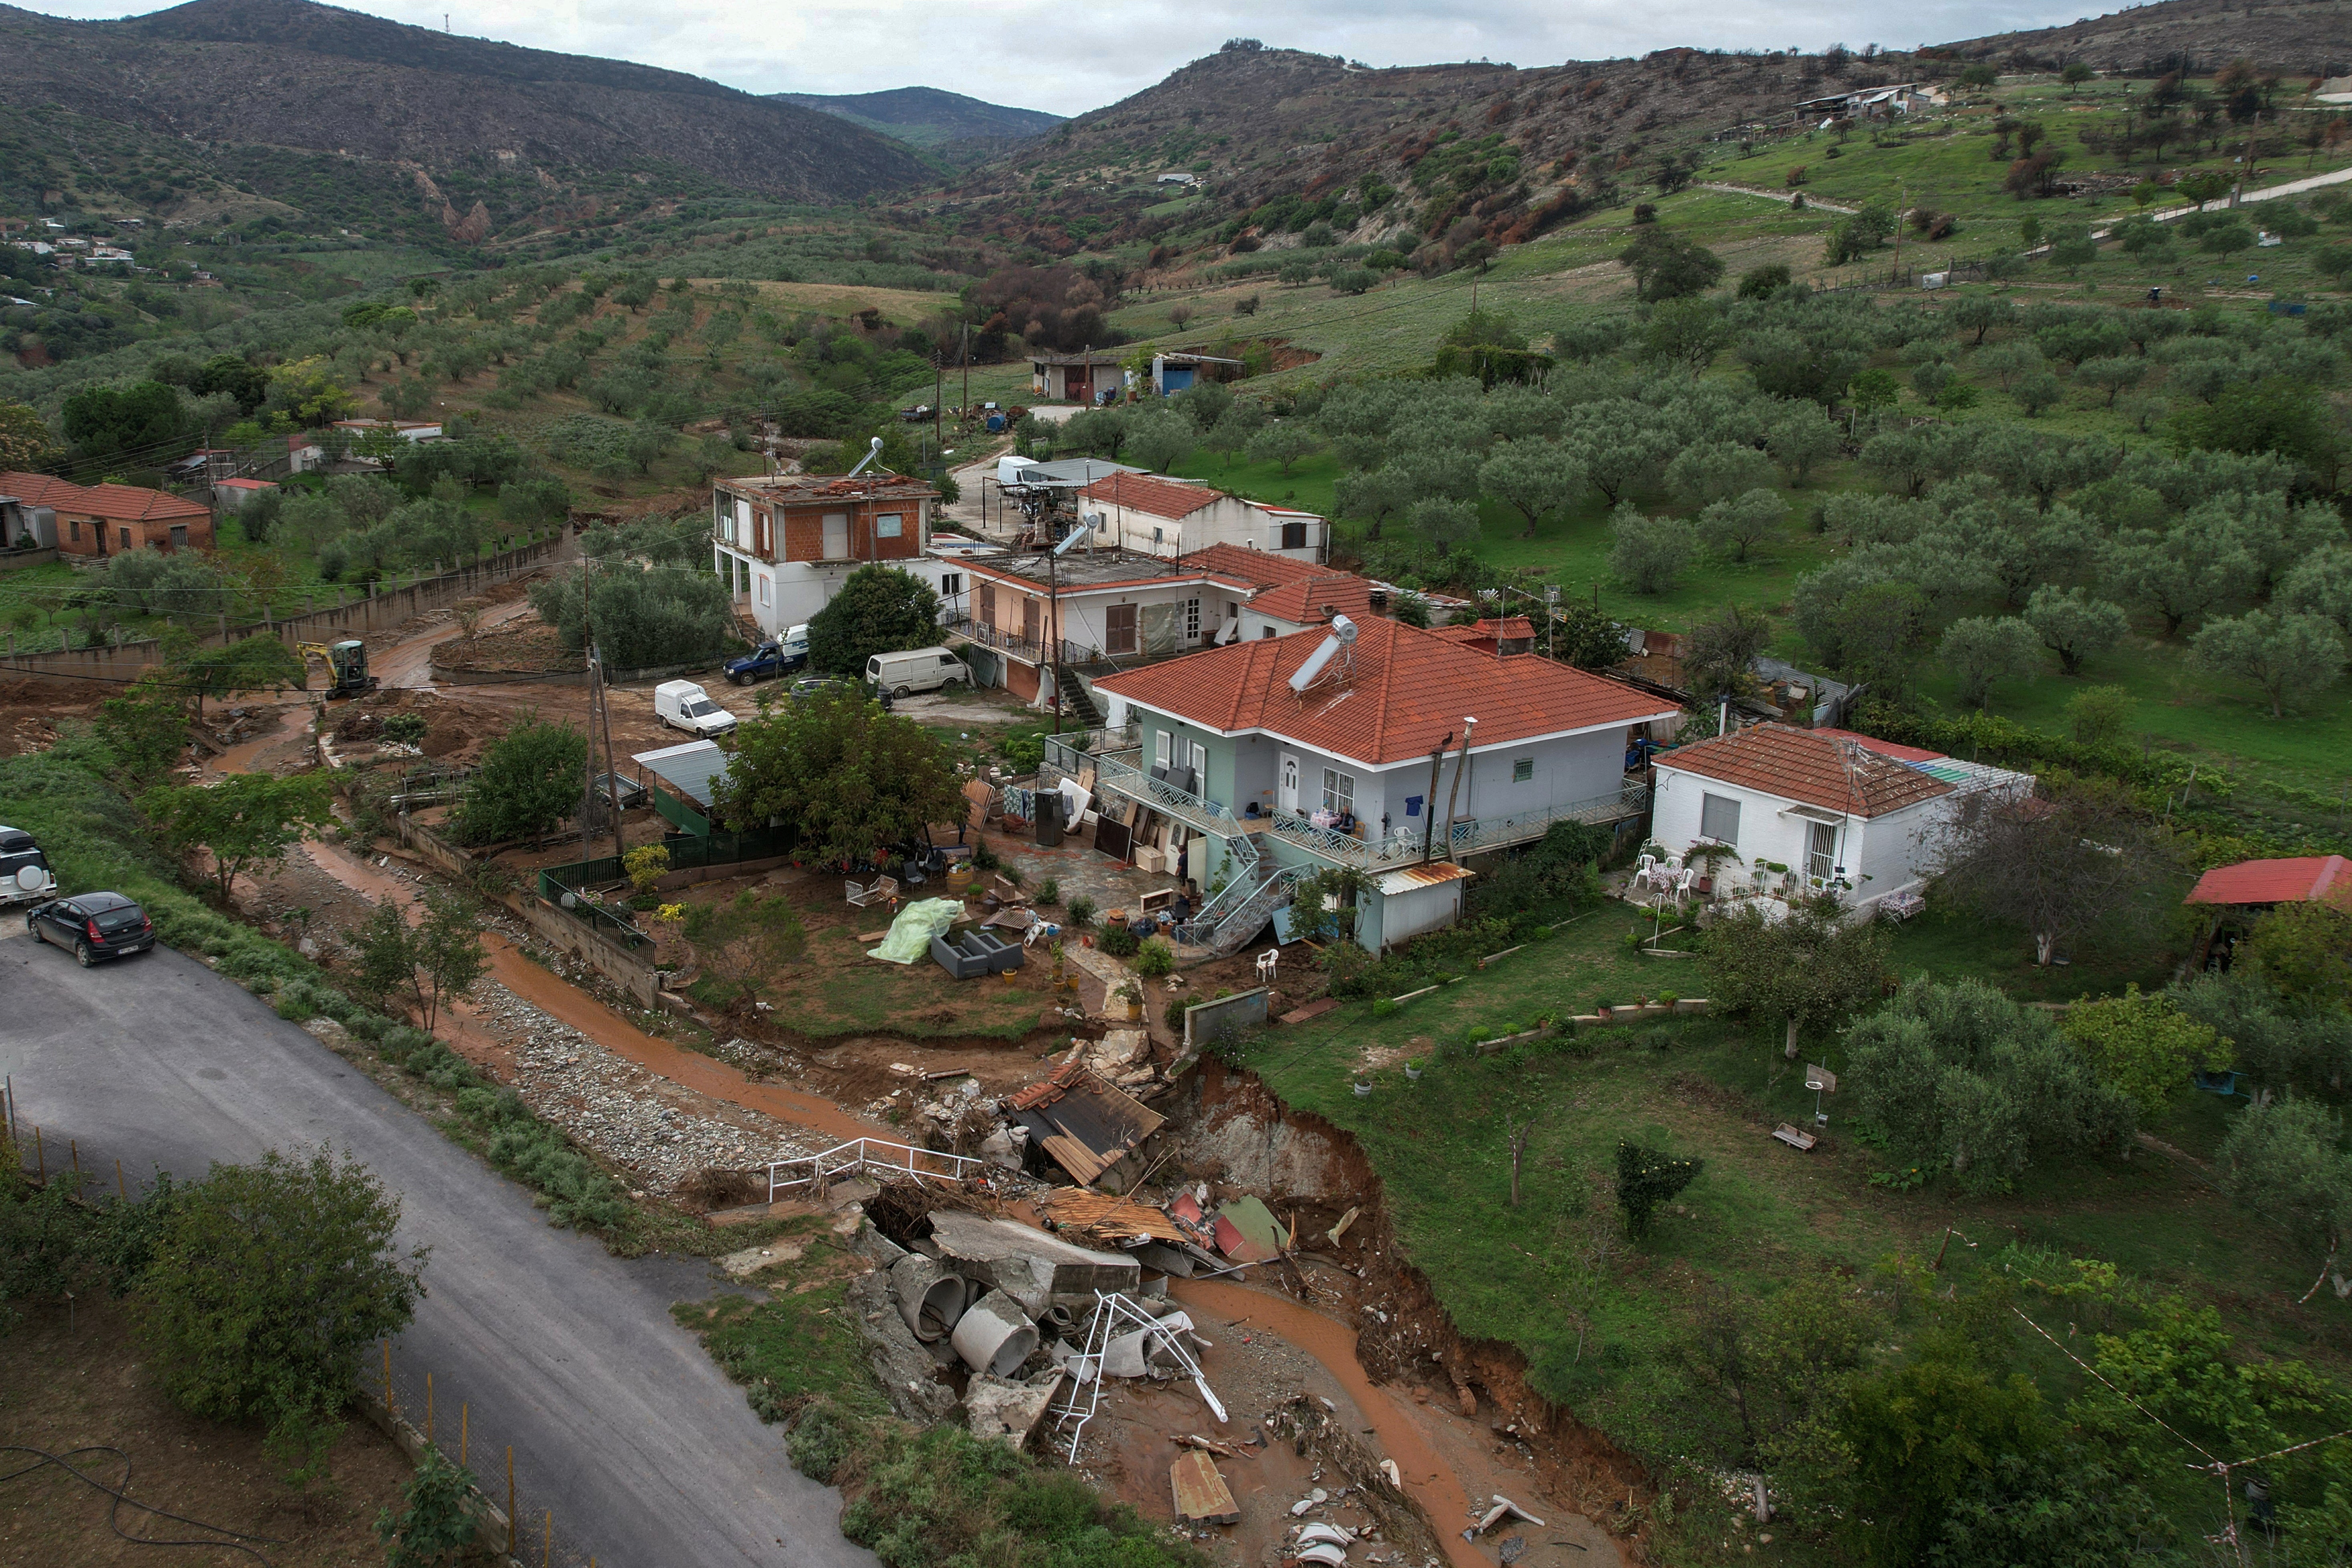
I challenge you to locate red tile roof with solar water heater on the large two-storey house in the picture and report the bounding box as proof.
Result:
[1096,618,1672,766]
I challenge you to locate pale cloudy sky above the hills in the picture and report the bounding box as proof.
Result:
[28,0,2110,115]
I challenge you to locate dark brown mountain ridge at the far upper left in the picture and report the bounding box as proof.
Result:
[0,0,922,217]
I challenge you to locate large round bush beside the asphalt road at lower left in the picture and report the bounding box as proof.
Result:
[132,1149,426,1455]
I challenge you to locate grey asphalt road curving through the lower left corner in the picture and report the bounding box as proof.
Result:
[0,910,875,1568]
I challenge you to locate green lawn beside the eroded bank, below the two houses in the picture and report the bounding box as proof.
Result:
[1244,905,2347,1563]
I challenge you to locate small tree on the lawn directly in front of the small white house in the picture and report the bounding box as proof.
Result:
[1698,896,1886,1060]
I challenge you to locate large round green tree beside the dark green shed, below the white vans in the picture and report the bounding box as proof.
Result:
[713,691,962,863]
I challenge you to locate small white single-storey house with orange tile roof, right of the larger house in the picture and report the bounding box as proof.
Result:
[1651,724,2034,910]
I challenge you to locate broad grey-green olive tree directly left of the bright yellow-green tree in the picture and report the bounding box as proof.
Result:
[1846,978,2136,1194]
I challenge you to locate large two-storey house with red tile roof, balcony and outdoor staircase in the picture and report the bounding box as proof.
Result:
[1049,616,1675,950]
